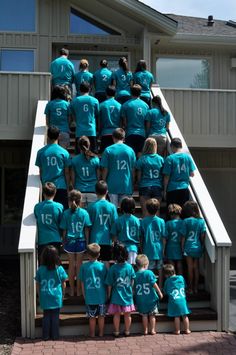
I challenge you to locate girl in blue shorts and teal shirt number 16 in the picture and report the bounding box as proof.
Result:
[60,190,91,296]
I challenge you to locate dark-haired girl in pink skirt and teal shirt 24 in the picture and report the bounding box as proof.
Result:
[106,244,135,337]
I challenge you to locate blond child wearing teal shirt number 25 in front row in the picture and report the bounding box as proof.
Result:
[134,254,163,335]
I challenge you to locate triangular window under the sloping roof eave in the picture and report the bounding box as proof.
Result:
[70,8,120,35]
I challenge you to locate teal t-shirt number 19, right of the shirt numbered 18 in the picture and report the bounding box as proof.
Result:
[141,216,166,260]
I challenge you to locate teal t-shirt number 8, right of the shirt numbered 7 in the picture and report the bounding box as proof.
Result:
[121,98,149,137]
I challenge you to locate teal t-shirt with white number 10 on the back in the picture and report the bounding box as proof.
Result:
[35,144,70,189]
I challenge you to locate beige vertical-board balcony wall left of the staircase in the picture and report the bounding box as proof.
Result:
[0,72,50,140]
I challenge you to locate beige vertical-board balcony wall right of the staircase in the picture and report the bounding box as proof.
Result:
[162,89,236,148]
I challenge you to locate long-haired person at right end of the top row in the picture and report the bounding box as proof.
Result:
[133,59,154,107]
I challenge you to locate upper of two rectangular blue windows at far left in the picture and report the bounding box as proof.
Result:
[0,0,36,32]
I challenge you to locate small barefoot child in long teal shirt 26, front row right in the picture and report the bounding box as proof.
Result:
[163,264,191,335]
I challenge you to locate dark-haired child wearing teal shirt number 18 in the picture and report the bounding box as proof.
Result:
[111,197,140,265]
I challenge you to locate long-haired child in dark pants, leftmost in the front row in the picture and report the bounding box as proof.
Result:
[35,245,68,340]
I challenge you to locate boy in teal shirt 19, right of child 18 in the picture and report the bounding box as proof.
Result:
[141,198,165,287]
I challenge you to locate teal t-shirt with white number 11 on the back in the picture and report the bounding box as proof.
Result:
[71,153,100,192]
